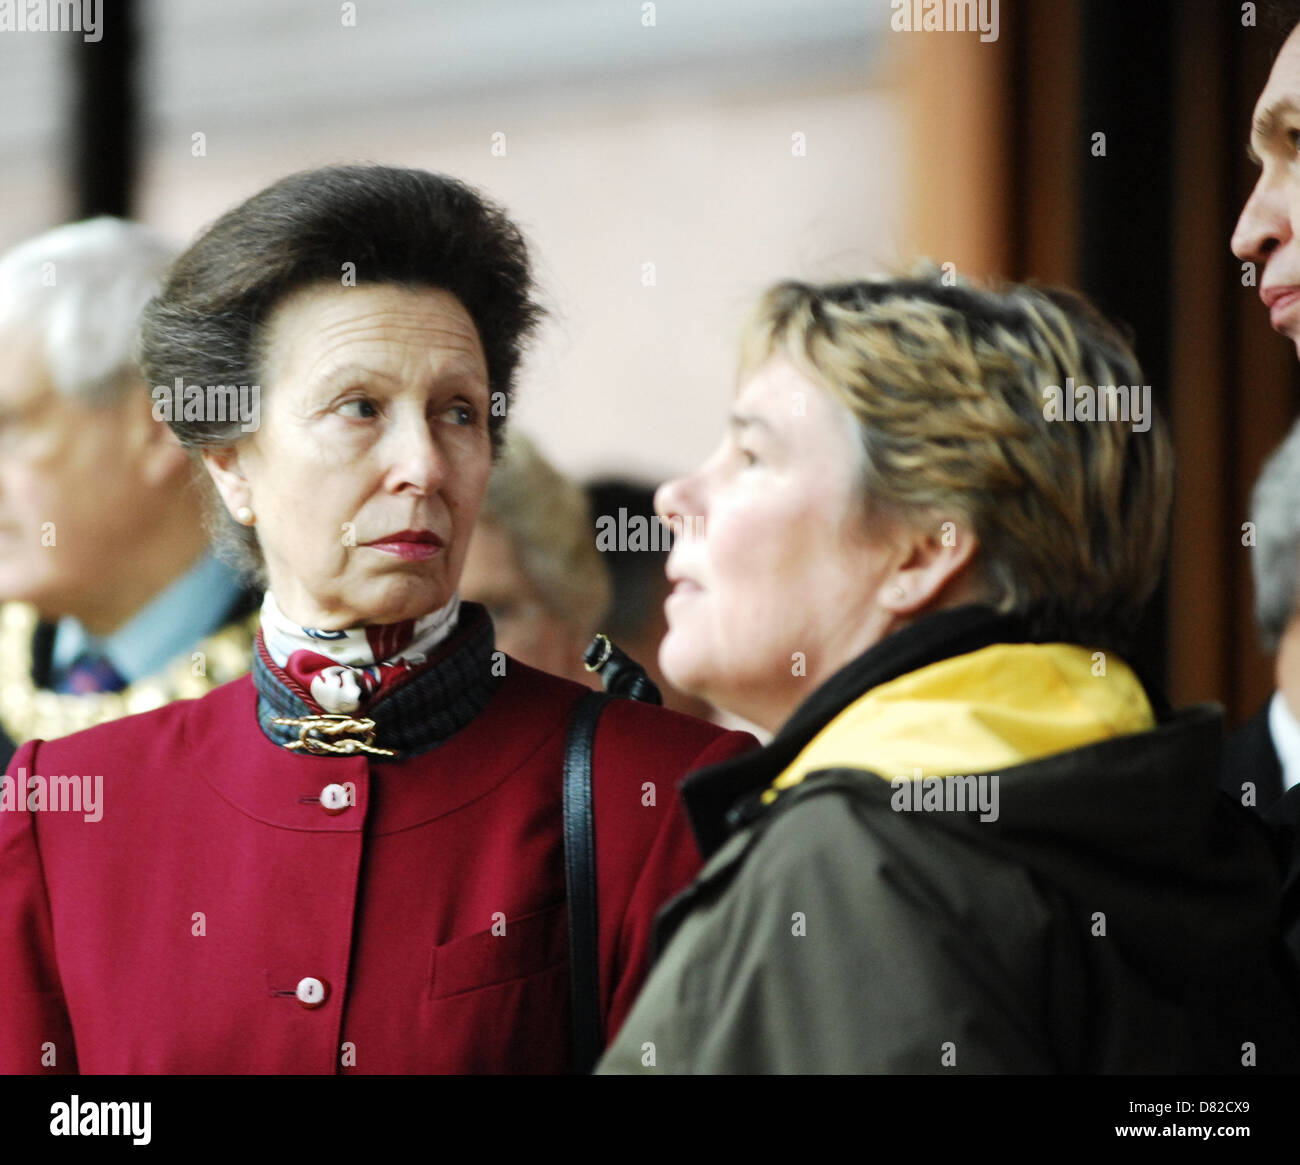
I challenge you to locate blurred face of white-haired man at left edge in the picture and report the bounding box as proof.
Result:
[0,328,160,623]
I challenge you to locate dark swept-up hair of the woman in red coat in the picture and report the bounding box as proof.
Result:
[140,165,545,575]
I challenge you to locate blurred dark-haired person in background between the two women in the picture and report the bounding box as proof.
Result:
[586,477,735,727]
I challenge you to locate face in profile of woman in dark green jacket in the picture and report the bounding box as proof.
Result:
[655,355,896,732]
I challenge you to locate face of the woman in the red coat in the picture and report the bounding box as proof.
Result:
[207,285,491,629]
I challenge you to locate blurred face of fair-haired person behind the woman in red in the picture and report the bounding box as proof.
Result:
[460,521,589,683]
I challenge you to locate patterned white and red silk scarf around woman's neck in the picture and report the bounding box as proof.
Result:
[261,590,460,714]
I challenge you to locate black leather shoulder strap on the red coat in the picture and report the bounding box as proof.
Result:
[564,692,610,1074]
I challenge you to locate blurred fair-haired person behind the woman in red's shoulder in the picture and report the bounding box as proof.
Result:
[460,433,611,688]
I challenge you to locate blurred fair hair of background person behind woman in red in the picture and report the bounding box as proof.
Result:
[480,433,611,635]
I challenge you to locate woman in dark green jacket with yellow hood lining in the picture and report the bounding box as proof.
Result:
[601,272,1300,1073]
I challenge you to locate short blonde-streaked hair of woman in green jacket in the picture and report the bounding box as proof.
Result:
[741,265,1173,648]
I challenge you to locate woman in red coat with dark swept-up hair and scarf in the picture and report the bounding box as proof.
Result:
[0,166,751,1073]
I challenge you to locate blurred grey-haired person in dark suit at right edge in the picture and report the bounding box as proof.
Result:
[1223,421,1300,813]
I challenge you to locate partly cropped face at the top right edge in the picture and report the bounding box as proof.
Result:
[1232,30,1300,351]
